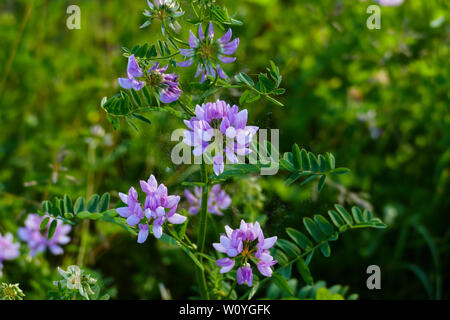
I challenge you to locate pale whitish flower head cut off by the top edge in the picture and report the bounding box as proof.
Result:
[141,0,184,34]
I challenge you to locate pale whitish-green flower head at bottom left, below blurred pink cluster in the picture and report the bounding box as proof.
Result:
[53,265,97,300]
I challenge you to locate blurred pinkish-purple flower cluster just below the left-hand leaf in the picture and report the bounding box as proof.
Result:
[18,213,72,257]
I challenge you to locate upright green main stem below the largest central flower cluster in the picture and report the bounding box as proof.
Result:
[197,160,209,300]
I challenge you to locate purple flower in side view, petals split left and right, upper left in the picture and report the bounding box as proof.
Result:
[119,54,183,103]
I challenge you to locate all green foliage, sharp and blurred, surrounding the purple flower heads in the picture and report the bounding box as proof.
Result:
[0,0,450,299]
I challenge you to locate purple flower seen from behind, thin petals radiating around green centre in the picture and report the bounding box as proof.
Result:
[178,22,239,83]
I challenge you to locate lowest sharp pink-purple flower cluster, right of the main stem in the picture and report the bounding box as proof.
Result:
[213,220,277,287]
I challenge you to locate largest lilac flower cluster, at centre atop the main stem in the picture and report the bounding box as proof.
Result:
[184,100,259,175]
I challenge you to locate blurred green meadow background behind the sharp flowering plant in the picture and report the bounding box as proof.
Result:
[0,0,450,299]
